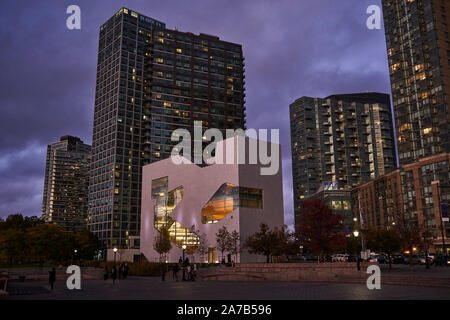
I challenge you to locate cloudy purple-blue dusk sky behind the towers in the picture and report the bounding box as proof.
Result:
[0,0,390,225]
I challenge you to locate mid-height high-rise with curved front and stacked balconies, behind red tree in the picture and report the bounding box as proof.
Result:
[290,93,396,226]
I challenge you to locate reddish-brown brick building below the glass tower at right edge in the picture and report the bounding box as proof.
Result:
[351,153,450,254]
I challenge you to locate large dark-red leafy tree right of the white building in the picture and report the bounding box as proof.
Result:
[297,199,345,260]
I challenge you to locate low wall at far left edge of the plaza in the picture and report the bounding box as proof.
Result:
[0,267,103,282]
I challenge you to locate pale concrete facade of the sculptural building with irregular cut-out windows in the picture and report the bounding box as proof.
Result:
[140,137,284,262]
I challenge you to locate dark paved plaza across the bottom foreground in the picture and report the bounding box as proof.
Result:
[9,277,450,300]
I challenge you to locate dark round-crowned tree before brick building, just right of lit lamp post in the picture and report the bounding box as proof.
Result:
[367,229,401,269]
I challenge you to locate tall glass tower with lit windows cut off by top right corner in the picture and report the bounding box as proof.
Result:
[383,0,450,165]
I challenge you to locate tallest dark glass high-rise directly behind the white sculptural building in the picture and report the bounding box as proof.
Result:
[89,8,245,256]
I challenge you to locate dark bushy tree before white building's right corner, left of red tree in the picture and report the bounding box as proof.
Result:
[244,223,277,263]
